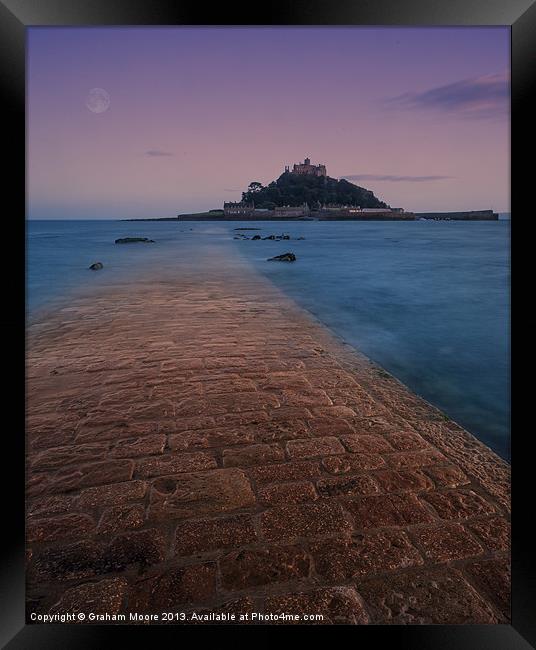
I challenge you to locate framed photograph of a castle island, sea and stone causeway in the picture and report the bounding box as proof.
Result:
[23,24,512,628]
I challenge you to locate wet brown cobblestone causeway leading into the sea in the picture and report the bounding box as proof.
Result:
[27,264,510,624]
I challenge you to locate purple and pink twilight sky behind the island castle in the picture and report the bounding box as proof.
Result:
[27,27,510,219]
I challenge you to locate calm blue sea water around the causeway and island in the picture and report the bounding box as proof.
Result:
[27,221,510,459]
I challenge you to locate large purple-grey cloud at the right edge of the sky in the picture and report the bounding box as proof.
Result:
[386,74,510,118]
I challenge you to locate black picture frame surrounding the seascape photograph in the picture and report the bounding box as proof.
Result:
[0,0,536,650]
